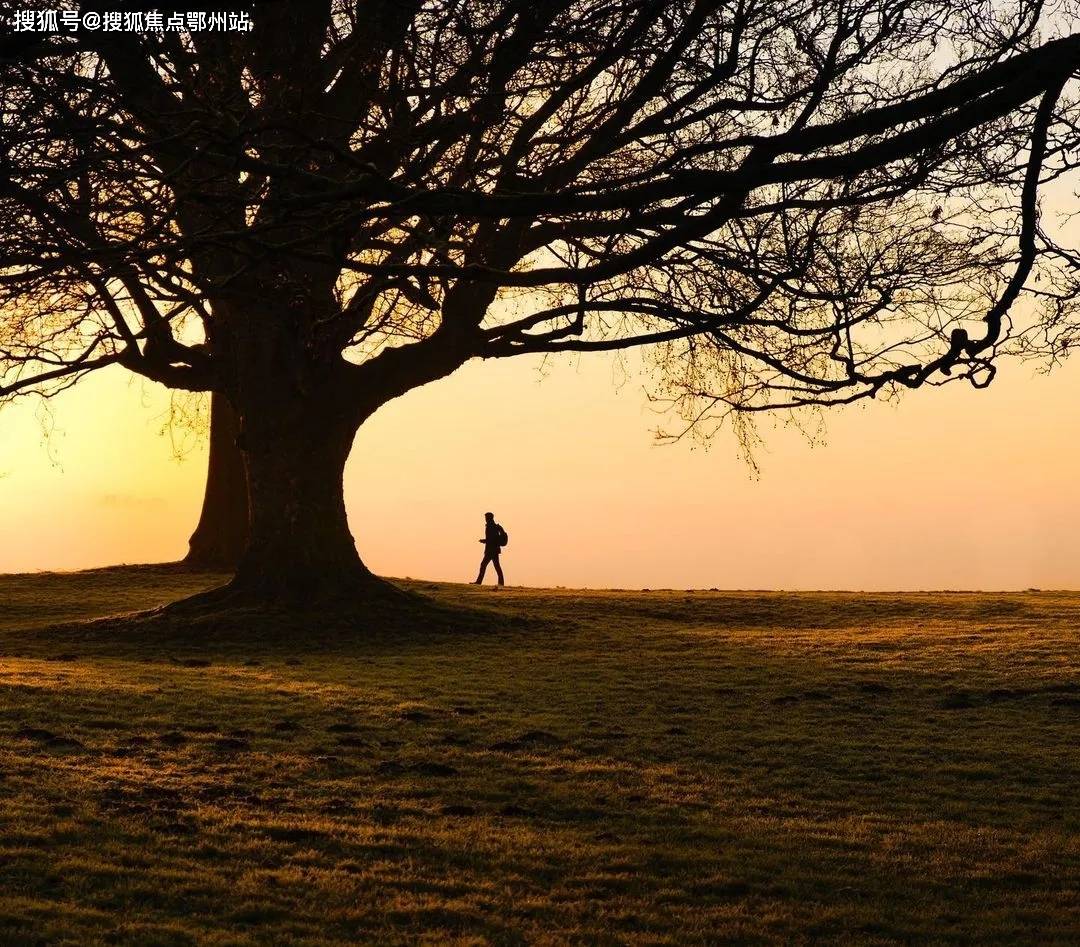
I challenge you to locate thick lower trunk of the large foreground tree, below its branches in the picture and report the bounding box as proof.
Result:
[230,409,392,607]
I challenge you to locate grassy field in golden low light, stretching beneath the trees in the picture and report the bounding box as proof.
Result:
[0,567,1080,945]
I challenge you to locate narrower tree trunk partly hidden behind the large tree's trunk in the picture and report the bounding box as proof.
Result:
[184,392,248,571]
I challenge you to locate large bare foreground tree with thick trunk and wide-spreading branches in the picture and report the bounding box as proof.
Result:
[0,0,1080,603]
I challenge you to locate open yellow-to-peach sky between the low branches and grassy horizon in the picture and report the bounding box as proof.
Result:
[0,341,1080,590]
